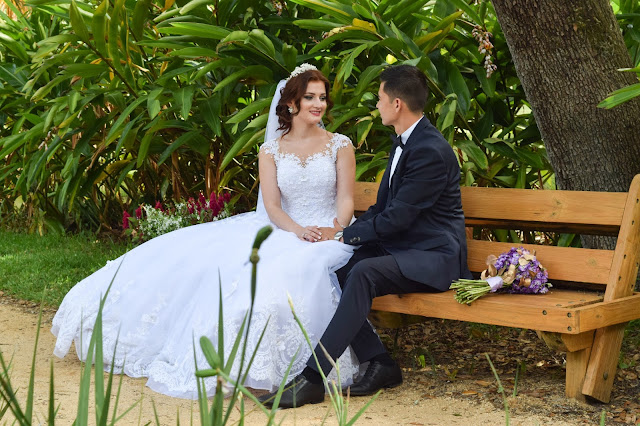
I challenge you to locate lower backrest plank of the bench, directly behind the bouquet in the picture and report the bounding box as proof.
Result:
[467,240,614,288]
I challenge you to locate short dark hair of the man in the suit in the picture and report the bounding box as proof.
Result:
[380,65,429,112]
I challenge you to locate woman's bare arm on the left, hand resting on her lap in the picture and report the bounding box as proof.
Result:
[258,150,321,240]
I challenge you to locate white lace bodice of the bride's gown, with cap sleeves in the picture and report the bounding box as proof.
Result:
[260,133,351,226]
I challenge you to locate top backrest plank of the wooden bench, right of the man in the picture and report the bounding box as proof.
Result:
[460,187,627,227]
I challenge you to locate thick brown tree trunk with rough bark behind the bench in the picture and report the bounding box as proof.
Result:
[493,0,640,196]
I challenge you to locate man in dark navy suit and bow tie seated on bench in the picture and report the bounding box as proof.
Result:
[262,65,471,408]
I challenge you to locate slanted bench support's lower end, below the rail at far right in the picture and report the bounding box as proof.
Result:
[582,323,626,402]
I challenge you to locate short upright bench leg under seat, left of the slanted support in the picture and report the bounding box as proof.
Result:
[561,331,594,401]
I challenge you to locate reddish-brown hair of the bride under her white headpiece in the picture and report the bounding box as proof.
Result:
[276,69,333,136]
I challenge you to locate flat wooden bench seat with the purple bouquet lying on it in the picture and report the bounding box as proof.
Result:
[372,290,602,334]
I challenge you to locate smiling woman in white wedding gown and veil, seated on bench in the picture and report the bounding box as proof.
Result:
[52,64,358,398]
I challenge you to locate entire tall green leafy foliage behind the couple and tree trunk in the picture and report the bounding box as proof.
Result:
[6,0,640,233]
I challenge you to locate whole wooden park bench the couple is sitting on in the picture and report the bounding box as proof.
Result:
[355,175,640,402]
